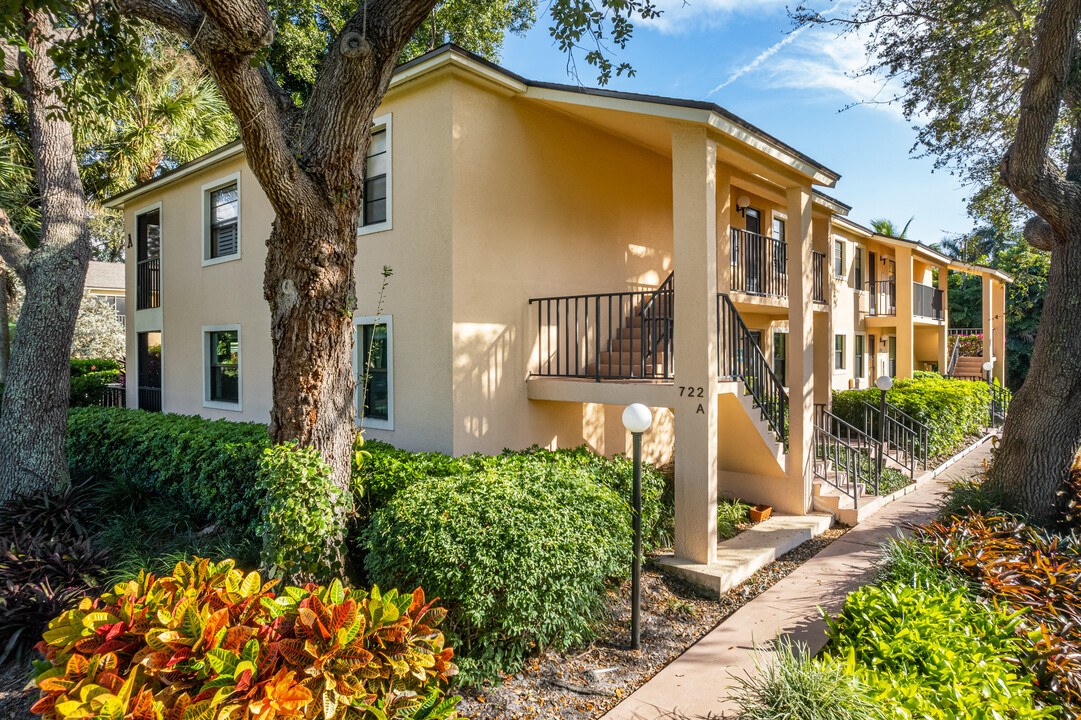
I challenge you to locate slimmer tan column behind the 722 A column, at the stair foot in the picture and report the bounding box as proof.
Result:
[777,182,812,515]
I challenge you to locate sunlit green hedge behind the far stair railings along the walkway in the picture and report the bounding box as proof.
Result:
[833,372,990,457]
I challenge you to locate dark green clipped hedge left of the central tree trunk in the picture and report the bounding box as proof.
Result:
[67,408,270,536]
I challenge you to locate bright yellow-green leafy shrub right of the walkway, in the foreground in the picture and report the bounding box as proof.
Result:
[827,585,1056,720]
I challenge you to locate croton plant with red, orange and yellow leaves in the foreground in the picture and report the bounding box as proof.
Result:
[32,559,457,720]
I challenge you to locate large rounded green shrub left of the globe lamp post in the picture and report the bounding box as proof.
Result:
[363,463,631,681]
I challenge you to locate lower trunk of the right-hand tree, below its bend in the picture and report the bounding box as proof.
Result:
[987,230,1081,520]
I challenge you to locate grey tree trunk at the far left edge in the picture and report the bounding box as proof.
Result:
[0,11,91,503]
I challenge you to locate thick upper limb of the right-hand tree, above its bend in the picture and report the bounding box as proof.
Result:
[999,0,1081,235]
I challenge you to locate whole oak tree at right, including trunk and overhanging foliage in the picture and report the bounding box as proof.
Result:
[795,0,1081,519]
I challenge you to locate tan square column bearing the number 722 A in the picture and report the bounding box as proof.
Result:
[672,125,730,563]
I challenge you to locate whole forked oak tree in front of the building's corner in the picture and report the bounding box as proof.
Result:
[101,0,656,562]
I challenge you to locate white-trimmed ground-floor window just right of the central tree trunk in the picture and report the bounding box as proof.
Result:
[352,315,395,430]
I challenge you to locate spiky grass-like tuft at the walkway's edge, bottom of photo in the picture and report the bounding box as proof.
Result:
[731,640,885,720]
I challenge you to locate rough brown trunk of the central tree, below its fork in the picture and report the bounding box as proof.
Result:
[264,206,356,566]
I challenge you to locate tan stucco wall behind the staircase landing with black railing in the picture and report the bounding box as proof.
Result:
[451,80,672,454]
